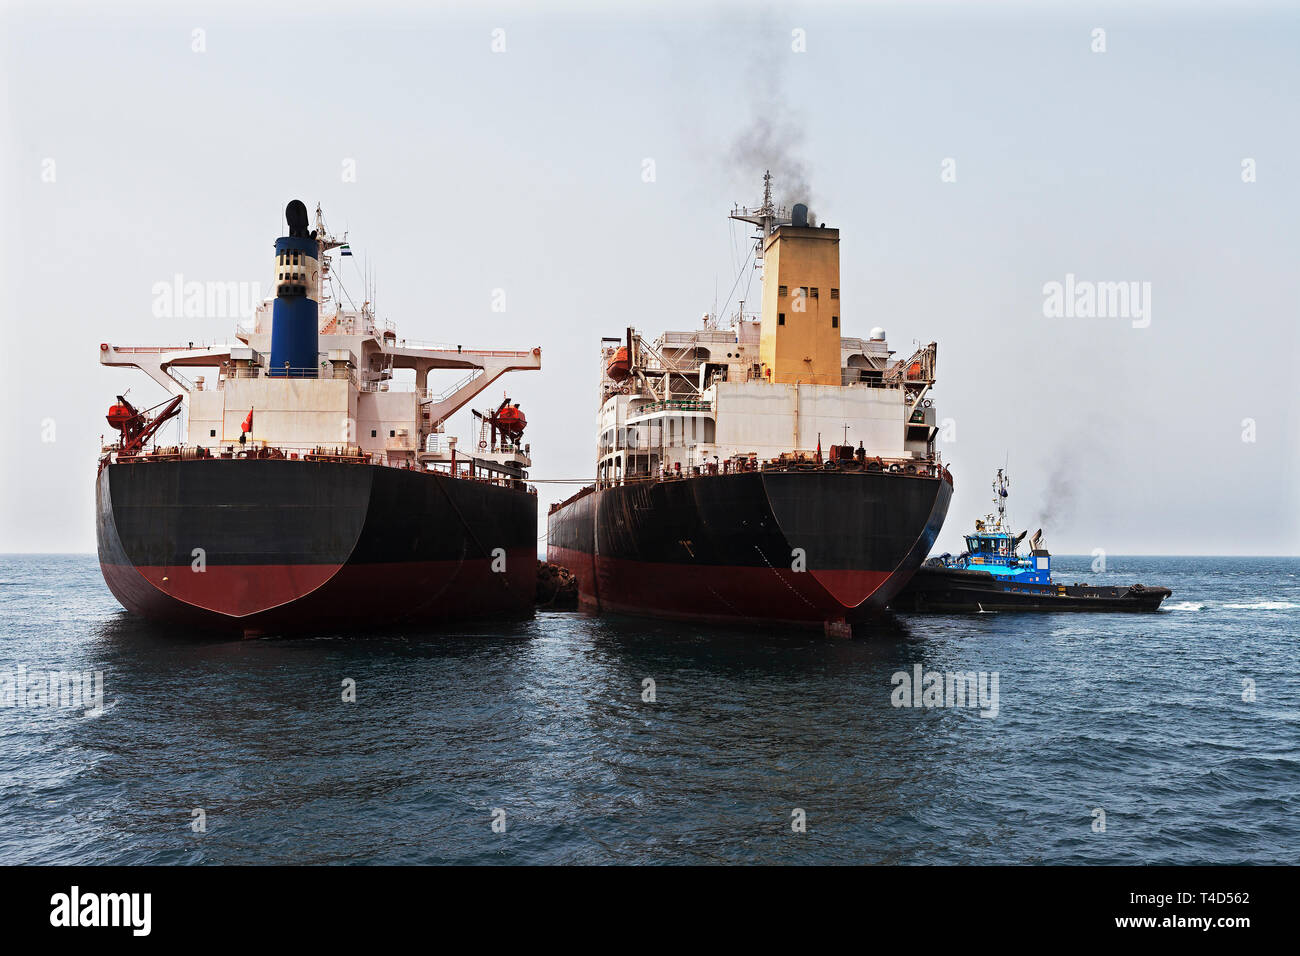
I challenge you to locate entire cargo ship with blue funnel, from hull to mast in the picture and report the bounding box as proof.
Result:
[98,200,541,632]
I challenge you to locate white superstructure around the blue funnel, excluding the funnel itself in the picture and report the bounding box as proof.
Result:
[99,207,542,475]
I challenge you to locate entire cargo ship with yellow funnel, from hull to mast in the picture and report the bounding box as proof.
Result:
[549,178,952,631]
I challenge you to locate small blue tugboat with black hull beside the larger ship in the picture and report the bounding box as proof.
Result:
[891,468,1174,611]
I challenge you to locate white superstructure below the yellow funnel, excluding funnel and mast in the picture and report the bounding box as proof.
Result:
[597,321,937,483]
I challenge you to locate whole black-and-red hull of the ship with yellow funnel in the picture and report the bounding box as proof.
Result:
[547,470,952,633]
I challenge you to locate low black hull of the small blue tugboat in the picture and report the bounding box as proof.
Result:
[891,566,1173,613]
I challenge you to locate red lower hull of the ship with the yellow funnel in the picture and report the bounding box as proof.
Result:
[549,548,910,635]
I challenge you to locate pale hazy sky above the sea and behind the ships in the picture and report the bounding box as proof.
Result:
[0,3,1300,554]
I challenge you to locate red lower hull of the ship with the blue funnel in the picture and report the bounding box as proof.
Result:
[100,549,537,636]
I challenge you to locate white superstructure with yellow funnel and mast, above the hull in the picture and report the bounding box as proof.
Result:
[597,176,940,484]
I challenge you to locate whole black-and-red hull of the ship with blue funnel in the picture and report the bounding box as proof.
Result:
[96,459,537,633]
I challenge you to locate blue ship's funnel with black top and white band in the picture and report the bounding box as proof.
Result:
[269,199,321,378]
